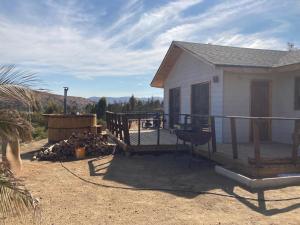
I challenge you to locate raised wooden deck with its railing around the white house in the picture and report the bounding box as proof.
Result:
[106,112,300,177]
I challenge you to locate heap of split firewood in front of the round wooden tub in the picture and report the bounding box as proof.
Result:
[33,132,116,161]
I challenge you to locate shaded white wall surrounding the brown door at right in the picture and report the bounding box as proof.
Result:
[223,72,300,143]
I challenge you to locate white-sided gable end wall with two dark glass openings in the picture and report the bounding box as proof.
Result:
[164,52,223,142]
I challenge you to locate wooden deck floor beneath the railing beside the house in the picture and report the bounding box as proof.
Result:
[129,129,300,177]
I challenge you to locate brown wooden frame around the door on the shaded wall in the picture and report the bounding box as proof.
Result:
[249,79,273,142]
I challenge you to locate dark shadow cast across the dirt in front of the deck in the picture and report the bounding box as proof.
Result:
[88,155,300,216]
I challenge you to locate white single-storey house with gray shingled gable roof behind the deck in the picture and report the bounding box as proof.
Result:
[151,41,300,143]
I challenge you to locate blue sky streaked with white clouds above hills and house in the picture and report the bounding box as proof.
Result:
[0,0,300,97]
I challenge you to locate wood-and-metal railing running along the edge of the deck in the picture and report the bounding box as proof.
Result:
[106,112,300,167]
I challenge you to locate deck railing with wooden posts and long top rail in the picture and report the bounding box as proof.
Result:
[106,112,300,167]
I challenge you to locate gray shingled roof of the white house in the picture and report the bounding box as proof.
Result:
[174,41,300,67]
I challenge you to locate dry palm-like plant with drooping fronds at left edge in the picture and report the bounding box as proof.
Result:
[0,65,38,222]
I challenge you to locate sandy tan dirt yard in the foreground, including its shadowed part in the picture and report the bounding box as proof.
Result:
[4,140,300,225]
